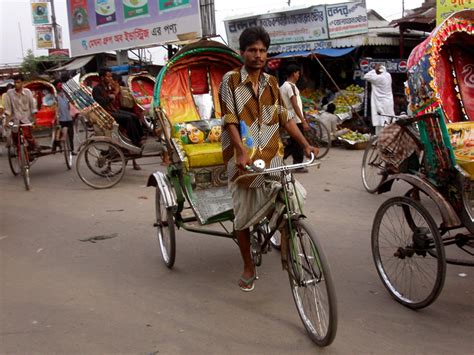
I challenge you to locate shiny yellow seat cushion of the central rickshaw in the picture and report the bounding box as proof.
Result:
[182,142,224,168]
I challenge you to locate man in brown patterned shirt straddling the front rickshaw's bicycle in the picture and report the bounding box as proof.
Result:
[219,27,318,291]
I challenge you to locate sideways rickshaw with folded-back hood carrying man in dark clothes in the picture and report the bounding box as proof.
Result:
[63,75,162,189]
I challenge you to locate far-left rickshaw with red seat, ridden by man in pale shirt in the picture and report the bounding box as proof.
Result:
[8,79,72,190]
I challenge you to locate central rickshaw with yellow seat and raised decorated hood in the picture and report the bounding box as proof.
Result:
[147,39,337,346]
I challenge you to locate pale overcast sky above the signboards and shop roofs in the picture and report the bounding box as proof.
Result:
[0,0,423,64]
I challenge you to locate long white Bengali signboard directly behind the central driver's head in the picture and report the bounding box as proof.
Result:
[224,6,328,49]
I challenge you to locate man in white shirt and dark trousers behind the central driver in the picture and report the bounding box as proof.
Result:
[280,64,309,173]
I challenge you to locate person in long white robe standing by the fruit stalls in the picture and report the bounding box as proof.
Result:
[364,63,395,135]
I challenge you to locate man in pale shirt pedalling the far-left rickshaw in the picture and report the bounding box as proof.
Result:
[4,74,39,152]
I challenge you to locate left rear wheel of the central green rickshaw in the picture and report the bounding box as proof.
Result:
[155,188,176,269]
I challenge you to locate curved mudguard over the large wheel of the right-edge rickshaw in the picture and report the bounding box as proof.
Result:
[377,174,461,228]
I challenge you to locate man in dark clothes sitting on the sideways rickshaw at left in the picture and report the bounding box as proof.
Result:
[92,68,143,170]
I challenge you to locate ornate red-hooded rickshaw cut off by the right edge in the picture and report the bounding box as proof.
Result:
[371,10,474,309]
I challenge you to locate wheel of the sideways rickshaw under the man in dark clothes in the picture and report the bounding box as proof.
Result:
[76,141,127,189]
